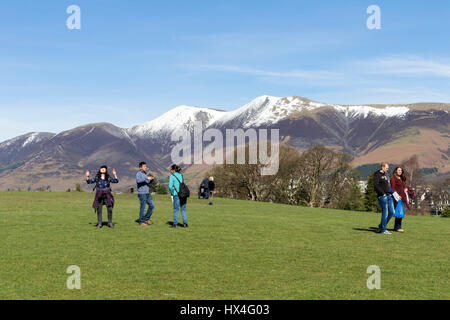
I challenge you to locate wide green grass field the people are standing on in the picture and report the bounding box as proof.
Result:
[0,192,450,300]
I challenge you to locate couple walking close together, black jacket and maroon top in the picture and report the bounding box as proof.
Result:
[373,162,414,234]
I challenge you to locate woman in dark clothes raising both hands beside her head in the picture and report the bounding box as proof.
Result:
[86,166,119,229]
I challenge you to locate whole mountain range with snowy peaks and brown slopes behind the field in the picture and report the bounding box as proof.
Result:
[0,95,450,190]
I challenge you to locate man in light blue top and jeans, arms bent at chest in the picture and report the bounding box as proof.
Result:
[136,162,155,227]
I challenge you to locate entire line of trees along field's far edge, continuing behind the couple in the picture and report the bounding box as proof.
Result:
[208,145,450,212]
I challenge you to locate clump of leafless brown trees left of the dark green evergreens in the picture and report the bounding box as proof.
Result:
[209,145,365,210]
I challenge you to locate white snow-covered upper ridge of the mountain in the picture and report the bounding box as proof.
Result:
[126,95,409,138]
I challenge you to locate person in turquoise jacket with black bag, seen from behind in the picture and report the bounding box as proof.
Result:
[169,164,190,228]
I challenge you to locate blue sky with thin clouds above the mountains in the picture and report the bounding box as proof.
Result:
[0,0,450,141]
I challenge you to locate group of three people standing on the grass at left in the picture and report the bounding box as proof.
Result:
[86,162,189,228]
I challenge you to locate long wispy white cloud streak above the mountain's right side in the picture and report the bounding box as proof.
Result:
[176,56,450,90]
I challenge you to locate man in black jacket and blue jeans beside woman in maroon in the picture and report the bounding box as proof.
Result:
[373,162,394,234]
